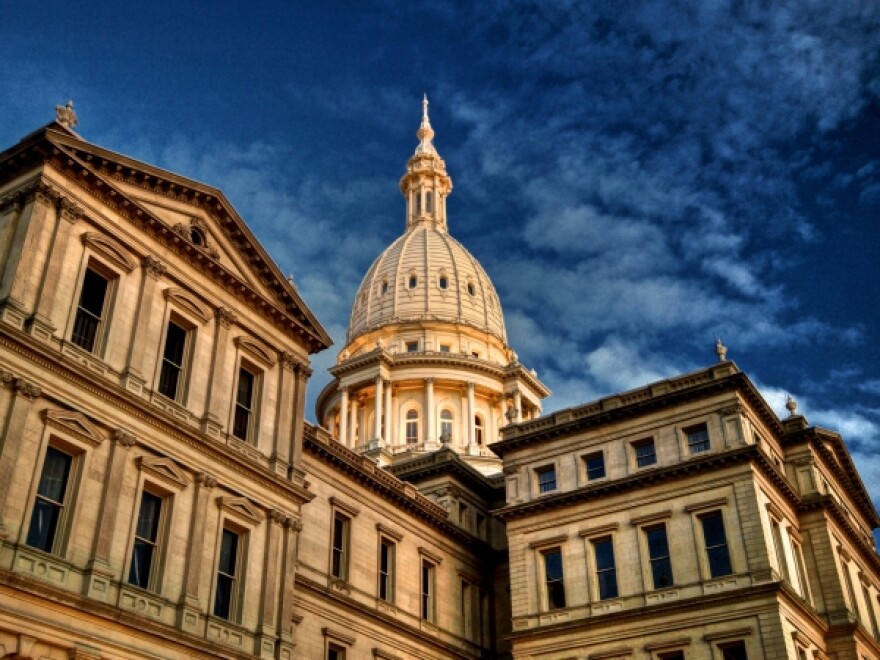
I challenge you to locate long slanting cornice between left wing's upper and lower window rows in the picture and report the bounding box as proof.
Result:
[0,324,315,508]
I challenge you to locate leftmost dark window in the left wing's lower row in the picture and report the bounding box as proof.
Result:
[27,447,73,552]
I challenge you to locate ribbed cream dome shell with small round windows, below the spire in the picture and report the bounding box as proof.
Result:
[348,222,507,343]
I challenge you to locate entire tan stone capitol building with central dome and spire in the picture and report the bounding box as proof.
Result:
[0,99,880,660]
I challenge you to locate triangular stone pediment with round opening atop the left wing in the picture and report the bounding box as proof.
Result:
[8,129,332,353]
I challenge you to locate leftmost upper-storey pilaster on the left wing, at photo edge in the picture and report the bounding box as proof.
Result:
[0,181,57,329]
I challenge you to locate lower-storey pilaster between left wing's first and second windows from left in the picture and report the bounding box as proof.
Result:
[85,429,136,600]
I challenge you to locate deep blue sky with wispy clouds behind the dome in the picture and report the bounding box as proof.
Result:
[0,0,880,498]
